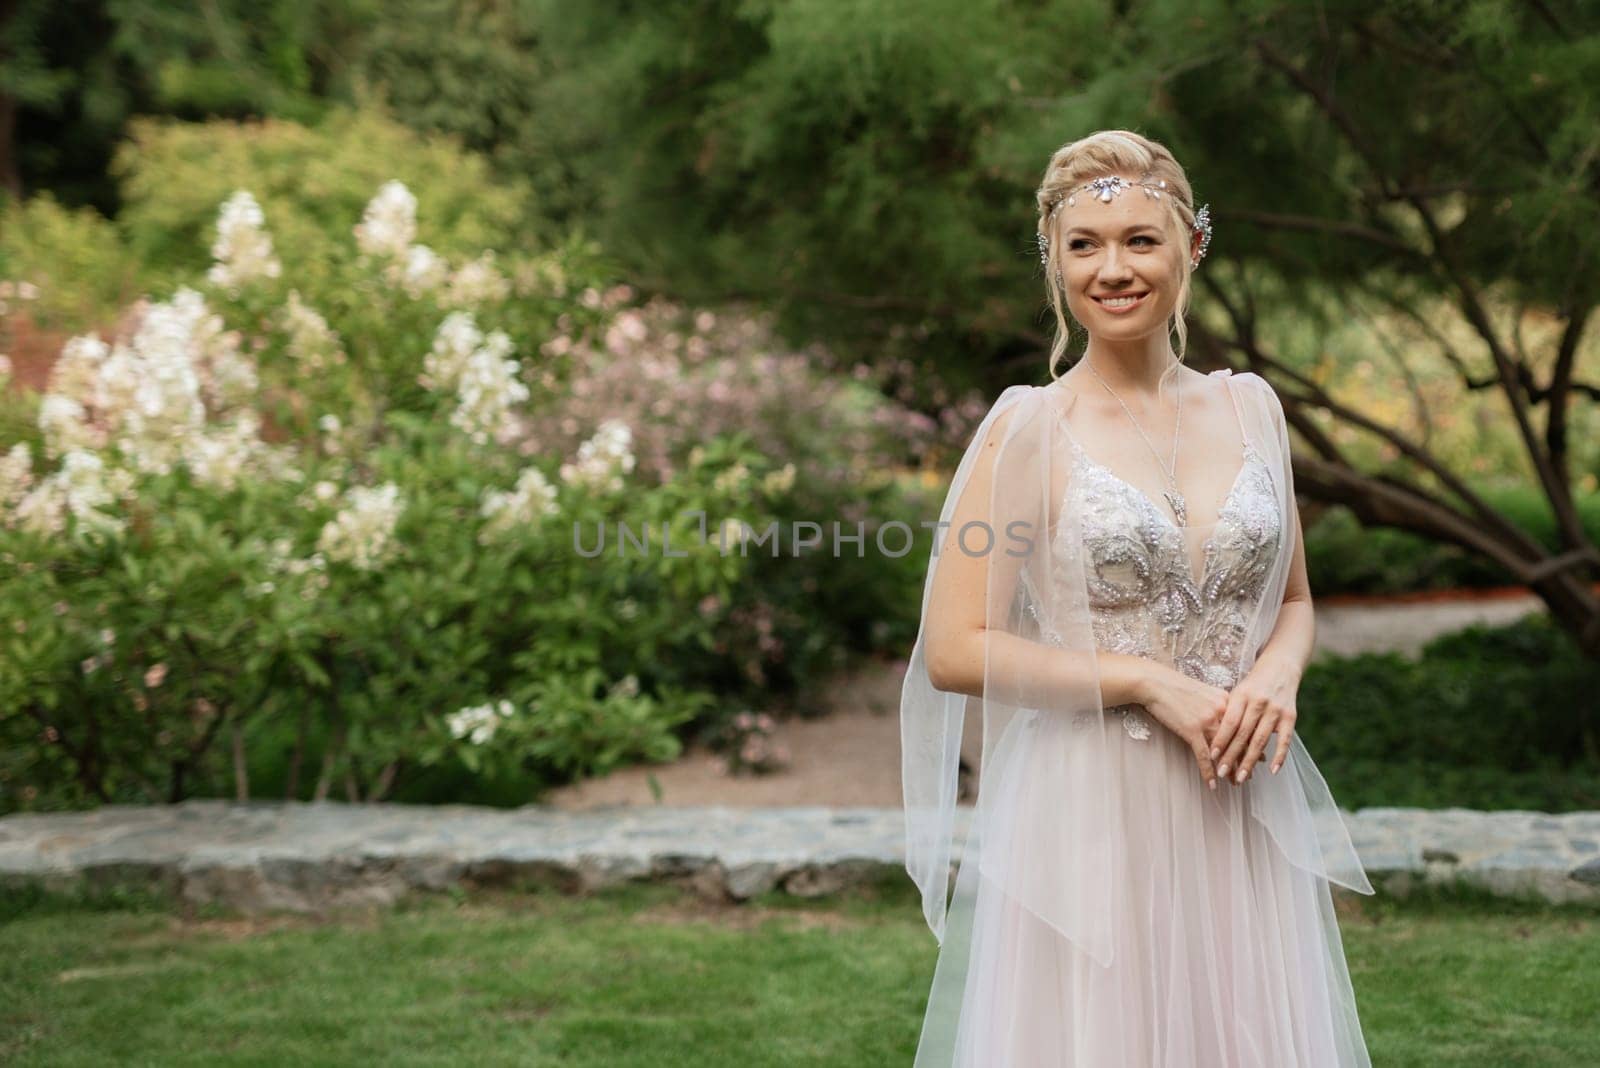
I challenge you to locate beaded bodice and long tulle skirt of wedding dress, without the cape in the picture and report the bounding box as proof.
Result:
[917,369,1371,1068]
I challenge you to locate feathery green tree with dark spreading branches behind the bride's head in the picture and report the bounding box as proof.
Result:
[438,0,1600,656]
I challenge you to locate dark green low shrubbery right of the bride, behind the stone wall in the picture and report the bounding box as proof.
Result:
[1298,616,1600,812]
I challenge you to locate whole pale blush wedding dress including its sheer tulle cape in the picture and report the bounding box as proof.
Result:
[901,371,1373,1068]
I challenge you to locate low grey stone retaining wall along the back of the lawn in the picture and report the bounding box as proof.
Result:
[0,801,1600,913]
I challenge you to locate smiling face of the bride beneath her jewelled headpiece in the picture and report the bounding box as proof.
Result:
[1056,176,1192,341]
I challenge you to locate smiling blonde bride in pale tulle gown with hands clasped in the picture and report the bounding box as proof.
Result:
[901,131,1373,1068]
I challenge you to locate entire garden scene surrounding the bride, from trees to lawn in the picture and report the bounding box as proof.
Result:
[0,0,1600,1068]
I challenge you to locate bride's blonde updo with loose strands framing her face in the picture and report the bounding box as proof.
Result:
[1037,130,1195,379]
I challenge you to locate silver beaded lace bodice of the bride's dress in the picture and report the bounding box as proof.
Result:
[1029,378,1282,742]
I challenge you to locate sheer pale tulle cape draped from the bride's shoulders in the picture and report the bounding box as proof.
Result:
[901,373,1373,959]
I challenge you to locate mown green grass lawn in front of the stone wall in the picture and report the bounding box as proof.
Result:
[0,886,1600,1068]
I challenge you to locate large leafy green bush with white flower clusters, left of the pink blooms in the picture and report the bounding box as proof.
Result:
[0,173,766,806]
